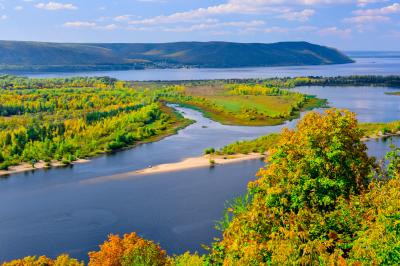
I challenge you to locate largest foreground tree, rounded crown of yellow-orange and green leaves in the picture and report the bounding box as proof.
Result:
[209,110,374,265]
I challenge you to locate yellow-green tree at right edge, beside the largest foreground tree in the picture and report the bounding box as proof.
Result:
[349,147,400,265]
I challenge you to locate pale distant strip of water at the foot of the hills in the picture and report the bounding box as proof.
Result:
[14,58,400,81]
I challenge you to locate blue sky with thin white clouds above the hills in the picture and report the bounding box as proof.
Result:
[0,0,400,50]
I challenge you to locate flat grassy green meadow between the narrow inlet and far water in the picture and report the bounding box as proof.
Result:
[161,83,326,126]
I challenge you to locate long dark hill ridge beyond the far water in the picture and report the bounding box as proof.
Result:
[0,41,352,71]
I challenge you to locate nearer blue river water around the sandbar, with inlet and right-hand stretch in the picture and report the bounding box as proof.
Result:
[0,84,400,261]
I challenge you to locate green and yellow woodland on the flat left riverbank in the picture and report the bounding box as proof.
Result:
[0,76,190,170]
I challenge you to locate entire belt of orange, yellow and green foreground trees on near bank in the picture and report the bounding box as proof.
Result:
[3,109,400,266]
